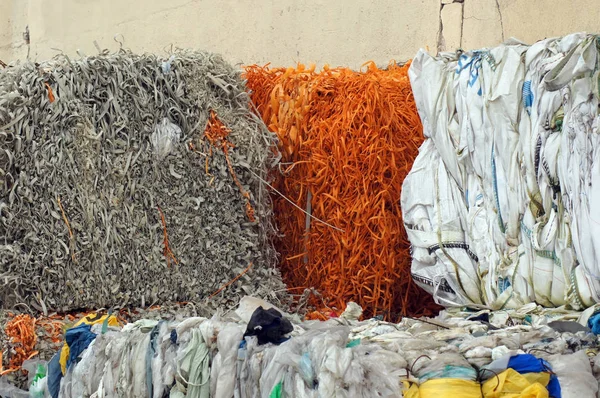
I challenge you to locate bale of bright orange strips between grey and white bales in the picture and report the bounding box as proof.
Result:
[245,63,439,320]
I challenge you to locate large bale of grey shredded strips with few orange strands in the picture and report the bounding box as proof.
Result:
[0,50,286,315]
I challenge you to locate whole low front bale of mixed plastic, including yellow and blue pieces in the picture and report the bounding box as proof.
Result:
[0,297,600,398]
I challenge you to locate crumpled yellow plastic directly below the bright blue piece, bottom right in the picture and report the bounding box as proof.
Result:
[482,369,552,398]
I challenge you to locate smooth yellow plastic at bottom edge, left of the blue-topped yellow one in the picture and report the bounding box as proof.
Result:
[404,379,482,398]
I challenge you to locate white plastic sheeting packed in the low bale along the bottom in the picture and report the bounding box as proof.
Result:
[5,303,600,398]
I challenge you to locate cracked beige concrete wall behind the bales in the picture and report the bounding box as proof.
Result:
[0,0,600,68]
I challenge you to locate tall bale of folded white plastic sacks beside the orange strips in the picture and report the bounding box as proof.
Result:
[402,34,600,309]
